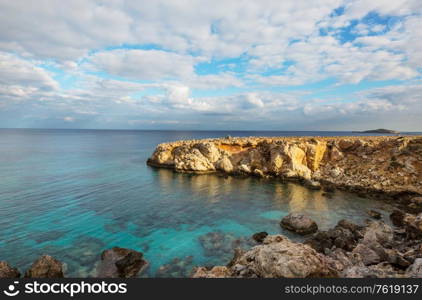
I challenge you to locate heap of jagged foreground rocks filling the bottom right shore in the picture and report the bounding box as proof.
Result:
[193,211,422,278]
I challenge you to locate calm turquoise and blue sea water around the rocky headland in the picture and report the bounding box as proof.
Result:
[0,129,408,277]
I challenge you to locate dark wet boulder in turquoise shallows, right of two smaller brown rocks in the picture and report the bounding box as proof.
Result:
[97,247,148,278]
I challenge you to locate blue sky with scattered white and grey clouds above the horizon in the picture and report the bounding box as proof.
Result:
[0,0,422,131]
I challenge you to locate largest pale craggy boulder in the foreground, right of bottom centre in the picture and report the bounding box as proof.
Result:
[193,235,337,278]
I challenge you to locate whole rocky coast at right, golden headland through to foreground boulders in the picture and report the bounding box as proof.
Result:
[147,136,422,278]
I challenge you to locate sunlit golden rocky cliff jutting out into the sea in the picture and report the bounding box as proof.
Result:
[148,136,422,194]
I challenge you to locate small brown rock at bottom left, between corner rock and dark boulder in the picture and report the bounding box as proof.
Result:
[25,255,64,278]
